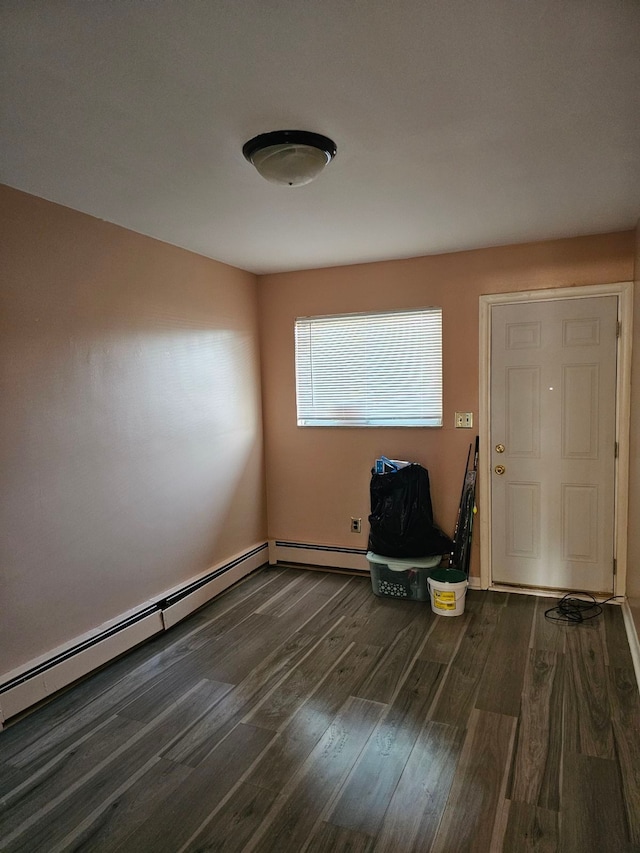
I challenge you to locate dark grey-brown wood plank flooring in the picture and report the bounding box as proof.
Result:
[0,568,640,853]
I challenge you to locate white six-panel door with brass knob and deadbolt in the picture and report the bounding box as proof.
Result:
[490,296,618,593]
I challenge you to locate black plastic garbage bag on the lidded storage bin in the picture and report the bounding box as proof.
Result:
[369,463,453,557]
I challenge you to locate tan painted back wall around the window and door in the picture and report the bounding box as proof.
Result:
[259,232,633,574]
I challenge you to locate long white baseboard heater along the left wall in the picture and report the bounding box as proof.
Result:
[0,542,268,728]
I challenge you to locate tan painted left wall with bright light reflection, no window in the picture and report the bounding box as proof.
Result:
[0,188,266,675]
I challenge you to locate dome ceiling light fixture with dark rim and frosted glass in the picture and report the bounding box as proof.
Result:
[242,130,337,187]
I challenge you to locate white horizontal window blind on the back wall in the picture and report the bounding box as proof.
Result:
[295,308,442,427]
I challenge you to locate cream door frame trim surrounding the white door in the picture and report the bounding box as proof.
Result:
[478,281,633,595]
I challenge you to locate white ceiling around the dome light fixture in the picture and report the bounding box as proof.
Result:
[0,0,640,273]
